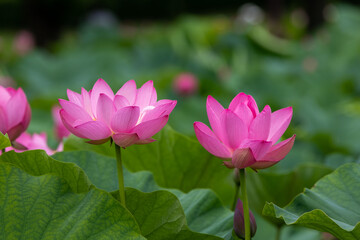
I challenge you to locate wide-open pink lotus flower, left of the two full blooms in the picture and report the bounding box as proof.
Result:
[59,79,176,147]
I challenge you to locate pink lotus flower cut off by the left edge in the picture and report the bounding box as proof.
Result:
[0,86,31,141]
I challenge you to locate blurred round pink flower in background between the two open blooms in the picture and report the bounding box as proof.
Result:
[173,73,199,96]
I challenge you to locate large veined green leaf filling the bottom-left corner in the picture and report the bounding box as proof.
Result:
[0,162,145,240]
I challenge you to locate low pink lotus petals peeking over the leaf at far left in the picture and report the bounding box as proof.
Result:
[5,132,63,155]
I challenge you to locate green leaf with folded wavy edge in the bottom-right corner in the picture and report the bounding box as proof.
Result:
[263,163,360,240]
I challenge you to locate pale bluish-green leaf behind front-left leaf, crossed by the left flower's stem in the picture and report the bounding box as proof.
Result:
[54,151,233,239]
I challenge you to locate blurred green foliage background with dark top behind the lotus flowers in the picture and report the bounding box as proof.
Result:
[0,0,360,239]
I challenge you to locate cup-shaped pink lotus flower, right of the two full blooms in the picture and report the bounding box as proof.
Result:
[194,93,295,169]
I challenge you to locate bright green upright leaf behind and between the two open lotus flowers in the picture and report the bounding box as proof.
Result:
[65,126,234,205]
